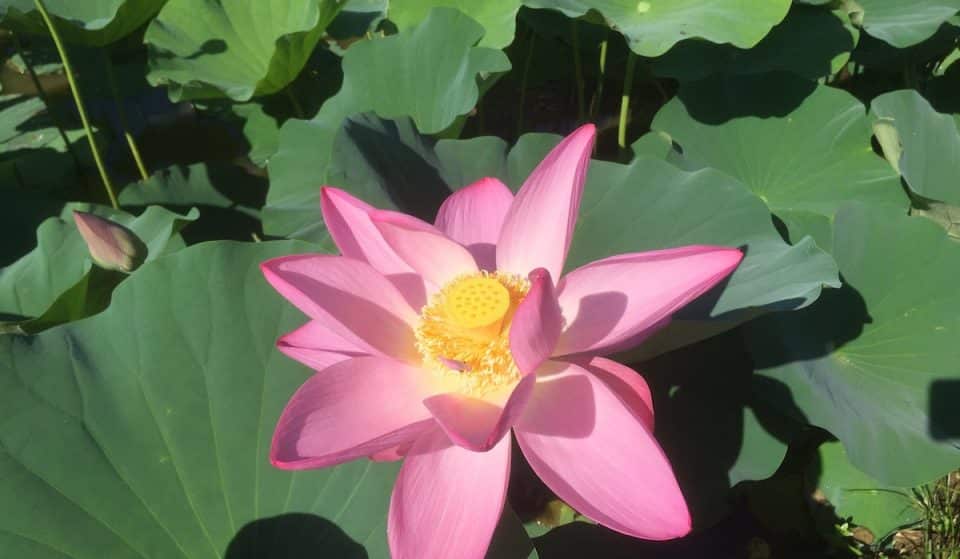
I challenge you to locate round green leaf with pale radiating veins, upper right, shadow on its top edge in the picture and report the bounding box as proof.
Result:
[652,73,909,241]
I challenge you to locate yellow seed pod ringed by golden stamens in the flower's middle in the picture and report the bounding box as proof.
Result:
[416,272,530,396]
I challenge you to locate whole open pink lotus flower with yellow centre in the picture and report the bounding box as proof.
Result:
[262,125,741,559]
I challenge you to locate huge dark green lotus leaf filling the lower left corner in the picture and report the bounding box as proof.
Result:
[0,242,531,559]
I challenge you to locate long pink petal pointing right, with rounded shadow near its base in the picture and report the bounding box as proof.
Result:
[554,246,743,355]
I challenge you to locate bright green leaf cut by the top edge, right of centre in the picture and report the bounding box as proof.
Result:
[523,0,790,56]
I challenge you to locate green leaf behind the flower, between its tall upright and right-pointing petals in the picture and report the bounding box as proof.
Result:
[508,134,839,319]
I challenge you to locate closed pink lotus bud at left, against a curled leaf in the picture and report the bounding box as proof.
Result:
[73,210,147,272]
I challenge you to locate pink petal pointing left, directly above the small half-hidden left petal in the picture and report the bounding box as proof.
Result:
[260,254,418,361]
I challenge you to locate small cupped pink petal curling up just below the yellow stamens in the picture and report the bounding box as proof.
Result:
[423,375,536,452]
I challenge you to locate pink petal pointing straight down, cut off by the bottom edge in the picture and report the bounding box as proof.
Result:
[387,429,510,559]
